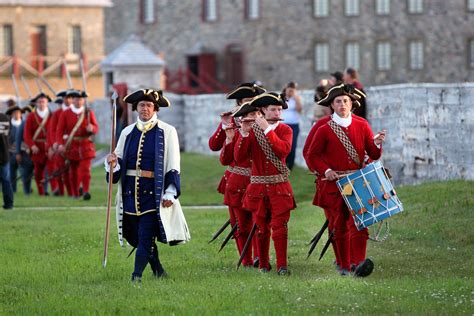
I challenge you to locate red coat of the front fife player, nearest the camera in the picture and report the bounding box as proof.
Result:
[234,122,296,215]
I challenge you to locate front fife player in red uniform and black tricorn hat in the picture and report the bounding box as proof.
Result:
[234,92,296,275]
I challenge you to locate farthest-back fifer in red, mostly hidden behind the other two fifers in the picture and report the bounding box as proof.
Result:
[209,83,265,258]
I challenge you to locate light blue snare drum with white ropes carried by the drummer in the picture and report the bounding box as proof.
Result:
[336,161,403,230]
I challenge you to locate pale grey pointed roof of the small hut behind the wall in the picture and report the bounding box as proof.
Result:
[101,35,165,67]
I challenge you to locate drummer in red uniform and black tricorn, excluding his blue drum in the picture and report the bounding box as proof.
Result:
[308,84,385,277]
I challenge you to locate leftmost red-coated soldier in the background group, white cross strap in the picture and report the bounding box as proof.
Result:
[23,92,57,195]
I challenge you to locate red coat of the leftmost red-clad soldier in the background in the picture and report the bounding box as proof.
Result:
[23,112,51,164]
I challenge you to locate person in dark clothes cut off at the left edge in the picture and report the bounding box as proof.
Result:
[0,113,13,210]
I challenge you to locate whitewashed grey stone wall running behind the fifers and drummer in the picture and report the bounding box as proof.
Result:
[94,84,474,184]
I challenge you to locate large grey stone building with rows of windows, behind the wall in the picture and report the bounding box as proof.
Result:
[105,0,474,89]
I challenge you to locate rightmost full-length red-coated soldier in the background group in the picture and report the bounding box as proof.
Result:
[56,91,99,200]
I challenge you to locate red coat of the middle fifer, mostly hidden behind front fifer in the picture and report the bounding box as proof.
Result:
[220,132,252,207]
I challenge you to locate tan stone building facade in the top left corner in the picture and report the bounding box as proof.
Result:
[0,0,112,73]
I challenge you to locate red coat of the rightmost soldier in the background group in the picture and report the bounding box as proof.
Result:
[56,109,99,161]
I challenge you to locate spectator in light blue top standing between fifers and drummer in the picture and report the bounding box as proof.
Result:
[282,81,303,169]
